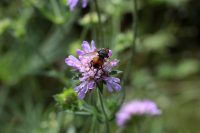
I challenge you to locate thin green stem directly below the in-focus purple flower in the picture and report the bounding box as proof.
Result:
[98,85,110,133]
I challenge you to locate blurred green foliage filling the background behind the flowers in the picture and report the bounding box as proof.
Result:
[0,0,200,133]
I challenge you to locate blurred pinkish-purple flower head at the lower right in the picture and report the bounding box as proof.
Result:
[116,100,161,126]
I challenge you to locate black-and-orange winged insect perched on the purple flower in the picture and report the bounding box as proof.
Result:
[84,48,109,69]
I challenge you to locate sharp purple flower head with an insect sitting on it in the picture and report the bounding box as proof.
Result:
[65,41,121,99]
